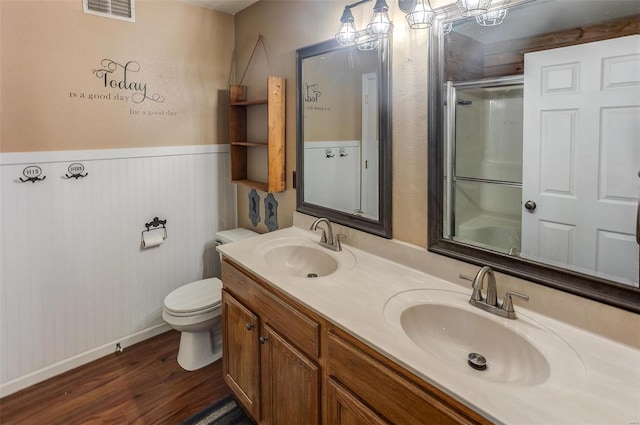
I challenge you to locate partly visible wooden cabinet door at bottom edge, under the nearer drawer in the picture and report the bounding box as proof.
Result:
[327,379,388,425]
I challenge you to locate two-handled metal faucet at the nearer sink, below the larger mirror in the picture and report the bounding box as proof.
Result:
[460,266,529,319]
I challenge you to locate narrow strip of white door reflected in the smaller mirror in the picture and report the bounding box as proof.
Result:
[360,72,379,220]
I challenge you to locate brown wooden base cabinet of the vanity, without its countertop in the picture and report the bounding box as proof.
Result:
[222,259,491,425]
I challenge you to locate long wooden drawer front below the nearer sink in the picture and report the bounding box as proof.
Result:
[327,329,491,425]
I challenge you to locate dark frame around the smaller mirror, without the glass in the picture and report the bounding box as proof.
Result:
[295,39,392,238]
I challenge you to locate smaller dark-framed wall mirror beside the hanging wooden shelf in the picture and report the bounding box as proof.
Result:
[296,39,391,238]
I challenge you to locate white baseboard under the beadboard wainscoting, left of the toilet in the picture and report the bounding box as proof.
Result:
[0,323,171,398]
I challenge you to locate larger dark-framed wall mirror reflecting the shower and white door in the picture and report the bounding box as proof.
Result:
[428,0,640,312]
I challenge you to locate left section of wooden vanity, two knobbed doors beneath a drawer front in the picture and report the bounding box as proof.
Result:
[222,261,321,425]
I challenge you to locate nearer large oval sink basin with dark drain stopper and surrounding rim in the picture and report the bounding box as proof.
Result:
[384,289,586,386]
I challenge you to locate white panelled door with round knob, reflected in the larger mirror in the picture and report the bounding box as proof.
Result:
[522,36,640,287]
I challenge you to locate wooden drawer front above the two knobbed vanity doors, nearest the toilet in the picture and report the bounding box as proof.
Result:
[222,260,321,360]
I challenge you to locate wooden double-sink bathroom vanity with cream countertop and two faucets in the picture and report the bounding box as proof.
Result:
[218,217,640,425]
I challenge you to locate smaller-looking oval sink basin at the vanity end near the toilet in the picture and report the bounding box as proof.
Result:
[260,238,355,279]
